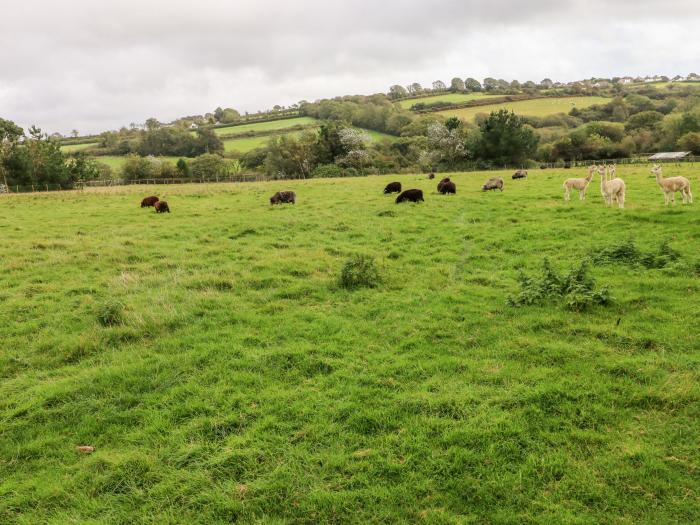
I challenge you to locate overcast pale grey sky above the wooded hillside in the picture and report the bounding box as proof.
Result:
[0,0,700,133]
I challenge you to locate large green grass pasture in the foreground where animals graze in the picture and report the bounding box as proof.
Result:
[0,167,700,524]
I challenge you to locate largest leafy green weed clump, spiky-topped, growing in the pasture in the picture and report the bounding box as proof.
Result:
[506,258,612,312]
